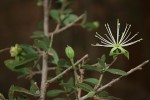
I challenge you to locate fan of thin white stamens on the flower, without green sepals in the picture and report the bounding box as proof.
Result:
[92,20,142,47]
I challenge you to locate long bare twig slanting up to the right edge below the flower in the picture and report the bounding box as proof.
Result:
[79,60,149,100]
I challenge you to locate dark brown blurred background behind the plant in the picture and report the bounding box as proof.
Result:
[0,0,150,100]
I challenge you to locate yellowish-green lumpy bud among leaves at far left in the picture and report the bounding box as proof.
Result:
[10,44,22,57]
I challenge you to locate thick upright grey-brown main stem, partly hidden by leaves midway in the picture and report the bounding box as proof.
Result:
[40,0,49,100]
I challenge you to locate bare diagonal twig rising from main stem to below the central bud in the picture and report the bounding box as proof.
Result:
[47,54,88,85]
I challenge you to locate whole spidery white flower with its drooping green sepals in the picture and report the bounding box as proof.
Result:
[92,20,142,59]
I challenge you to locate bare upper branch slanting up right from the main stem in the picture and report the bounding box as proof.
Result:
[49,14,85,36]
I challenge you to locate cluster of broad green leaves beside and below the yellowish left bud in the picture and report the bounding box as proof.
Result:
[4,45,38,74]
